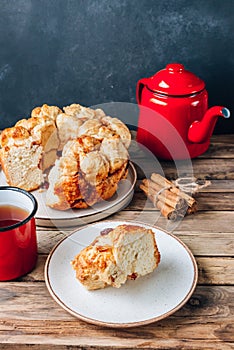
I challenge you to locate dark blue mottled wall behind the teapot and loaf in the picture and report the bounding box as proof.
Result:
[0,0,234,133]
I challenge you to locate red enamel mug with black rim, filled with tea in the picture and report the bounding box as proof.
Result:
[0,186,37,281]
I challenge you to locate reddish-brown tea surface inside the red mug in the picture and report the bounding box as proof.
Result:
[0,205,29,228]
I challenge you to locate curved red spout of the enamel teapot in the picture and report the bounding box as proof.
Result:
[188,106,230,143]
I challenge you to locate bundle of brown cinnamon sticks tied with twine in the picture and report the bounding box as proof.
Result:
[140,173,197,220]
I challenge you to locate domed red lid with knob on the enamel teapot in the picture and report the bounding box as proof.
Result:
[147,63,205,96]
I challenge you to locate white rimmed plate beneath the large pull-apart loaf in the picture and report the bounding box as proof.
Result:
[0,162,137,228]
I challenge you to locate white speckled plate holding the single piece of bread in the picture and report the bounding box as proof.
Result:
[45,221,198,327]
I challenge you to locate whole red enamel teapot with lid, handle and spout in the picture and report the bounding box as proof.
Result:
[136,63,230,159]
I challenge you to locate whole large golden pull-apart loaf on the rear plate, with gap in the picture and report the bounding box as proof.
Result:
[0,104,131,210]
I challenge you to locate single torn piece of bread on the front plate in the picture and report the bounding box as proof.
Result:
[71,225,160,290]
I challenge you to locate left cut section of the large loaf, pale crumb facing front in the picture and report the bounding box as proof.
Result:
[0,116,59,191]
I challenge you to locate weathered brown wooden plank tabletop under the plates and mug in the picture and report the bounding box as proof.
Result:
[0,135,234,350]
